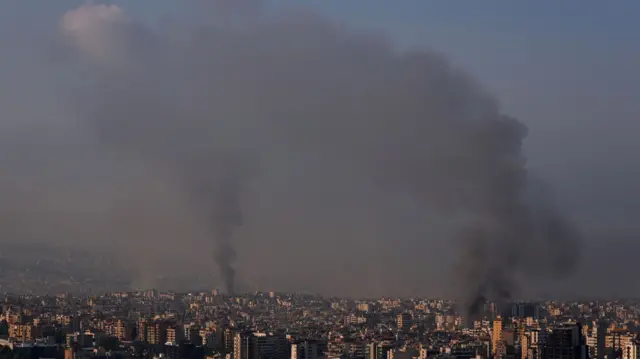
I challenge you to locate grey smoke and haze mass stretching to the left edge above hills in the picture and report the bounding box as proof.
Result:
[0,5,632,302]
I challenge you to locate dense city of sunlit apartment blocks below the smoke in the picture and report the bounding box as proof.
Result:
[0,290,640,359]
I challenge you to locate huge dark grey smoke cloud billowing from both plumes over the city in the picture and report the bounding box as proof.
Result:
[0,5,578,300]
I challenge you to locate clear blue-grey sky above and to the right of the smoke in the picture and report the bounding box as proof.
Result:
[0,0,640,294]
